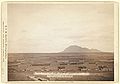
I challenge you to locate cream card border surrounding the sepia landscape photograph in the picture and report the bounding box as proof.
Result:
[0,1,120,84]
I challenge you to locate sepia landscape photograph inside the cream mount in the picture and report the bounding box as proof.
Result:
[7,2,115,81]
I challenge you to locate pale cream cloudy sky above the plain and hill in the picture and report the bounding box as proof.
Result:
[8,3,114,53]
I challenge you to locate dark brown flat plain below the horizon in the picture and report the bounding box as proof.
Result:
[8,53,114,81]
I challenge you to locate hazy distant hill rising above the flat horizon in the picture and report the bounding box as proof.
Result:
[62,45,101,53]
